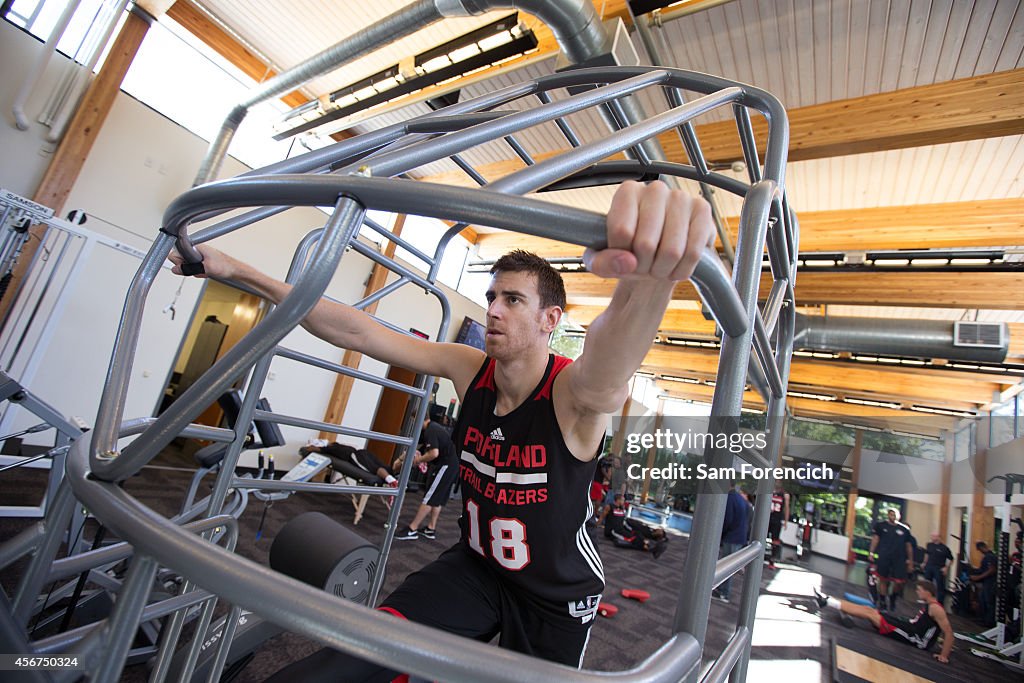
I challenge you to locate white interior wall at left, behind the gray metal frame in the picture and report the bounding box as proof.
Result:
[0,22,483,466]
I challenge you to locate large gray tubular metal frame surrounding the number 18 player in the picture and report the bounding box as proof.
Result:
[0,6,799,682]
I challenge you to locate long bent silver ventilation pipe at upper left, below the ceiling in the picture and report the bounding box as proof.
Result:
[194,0,618,185]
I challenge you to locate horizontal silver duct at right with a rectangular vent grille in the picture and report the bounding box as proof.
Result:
[794,313,1010,362]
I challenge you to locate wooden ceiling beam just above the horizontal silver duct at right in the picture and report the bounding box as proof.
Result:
[562,270,1024,310]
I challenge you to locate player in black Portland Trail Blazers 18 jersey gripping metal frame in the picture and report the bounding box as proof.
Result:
[172,181,715,683]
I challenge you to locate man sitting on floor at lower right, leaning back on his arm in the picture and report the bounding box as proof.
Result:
[814,579,953,664]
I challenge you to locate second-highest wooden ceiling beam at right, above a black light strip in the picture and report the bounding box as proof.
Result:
[477,198,1024,259]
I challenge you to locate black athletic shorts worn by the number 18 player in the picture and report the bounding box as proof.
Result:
[380,545,601,668]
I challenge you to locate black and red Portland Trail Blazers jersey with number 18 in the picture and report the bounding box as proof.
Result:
[455,355,604,601]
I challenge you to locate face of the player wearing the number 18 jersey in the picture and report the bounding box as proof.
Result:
[484,271,562,360]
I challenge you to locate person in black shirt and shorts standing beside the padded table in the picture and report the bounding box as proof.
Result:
[394,418,459,541]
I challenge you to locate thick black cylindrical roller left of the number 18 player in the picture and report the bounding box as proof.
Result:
[270,512,380,602]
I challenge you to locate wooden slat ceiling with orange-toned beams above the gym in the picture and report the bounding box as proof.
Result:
[179,0,1024,417]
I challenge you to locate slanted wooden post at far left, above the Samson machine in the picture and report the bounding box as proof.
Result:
[0,6,153,331]
